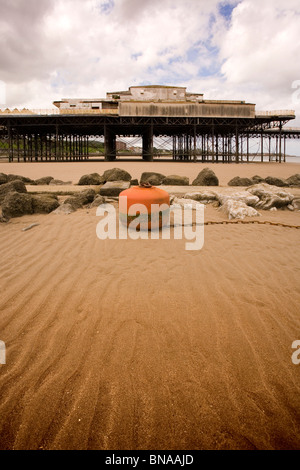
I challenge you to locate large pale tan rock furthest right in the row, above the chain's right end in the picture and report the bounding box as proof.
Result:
[248,183,294,210]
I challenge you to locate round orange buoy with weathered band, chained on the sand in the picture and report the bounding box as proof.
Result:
[119,184,170,229]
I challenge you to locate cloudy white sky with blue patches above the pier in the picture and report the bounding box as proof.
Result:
[0,0,300,154]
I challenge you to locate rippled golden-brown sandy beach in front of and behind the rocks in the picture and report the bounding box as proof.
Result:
[0,161,300,450]
